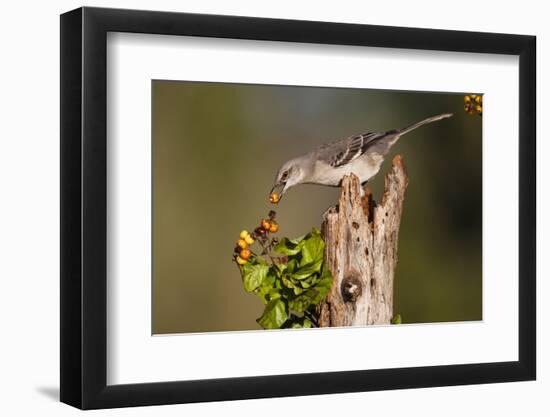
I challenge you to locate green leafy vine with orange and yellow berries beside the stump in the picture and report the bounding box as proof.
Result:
[233,211,332,329]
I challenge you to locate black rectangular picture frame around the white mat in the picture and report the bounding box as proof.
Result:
[60,7,536,409]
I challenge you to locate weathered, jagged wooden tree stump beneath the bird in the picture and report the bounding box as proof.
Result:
[319,155,409,327]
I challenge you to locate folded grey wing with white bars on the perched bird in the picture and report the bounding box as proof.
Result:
[317,131,398,168]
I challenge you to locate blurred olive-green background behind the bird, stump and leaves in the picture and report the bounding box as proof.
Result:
[152,81,482,334]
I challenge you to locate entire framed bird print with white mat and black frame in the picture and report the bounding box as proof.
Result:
[61,8,536,409]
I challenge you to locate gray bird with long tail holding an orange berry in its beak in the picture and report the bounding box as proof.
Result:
[271,113,452,201]
